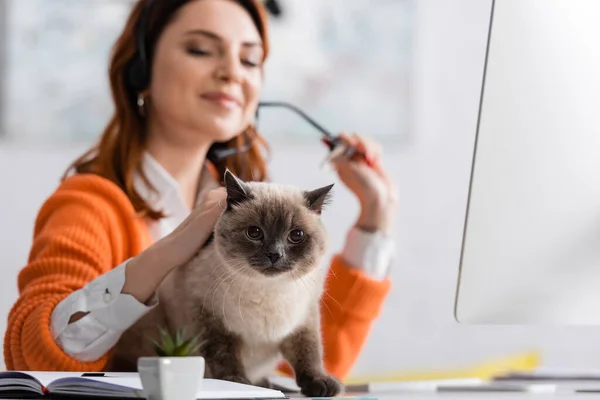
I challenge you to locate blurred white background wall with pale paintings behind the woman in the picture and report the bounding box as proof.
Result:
[0,0,600,376]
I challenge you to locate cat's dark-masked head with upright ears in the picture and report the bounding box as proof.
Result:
[215,171,333,279]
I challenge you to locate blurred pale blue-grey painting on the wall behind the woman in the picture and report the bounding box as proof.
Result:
[0,0,416,144]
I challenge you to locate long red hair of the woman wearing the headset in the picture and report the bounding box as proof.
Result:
[65,0,269,219]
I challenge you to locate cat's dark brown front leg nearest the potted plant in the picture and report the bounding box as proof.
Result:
[198,311,250,384]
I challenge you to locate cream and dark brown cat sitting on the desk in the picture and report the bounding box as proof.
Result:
[113,172,340,396]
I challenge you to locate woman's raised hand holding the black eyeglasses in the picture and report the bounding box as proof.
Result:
[331,134,398,232]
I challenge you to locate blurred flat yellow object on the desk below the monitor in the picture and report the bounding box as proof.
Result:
[344,352,541,385]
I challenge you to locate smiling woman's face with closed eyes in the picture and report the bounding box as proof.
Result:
[150,0,263,145]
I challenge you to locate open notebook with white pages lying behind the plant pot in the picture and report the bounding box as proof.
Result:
[0,371,287,400]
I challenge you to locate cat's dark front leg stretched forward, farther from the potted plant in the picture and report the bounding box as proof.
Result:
[280,327,343,397]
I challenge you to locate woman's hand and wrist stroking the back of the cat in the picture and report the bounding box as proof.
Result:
[121,188,227,303]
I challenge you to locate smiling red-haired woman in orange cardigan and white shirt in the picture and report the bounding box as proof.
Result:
[5,0,398,384]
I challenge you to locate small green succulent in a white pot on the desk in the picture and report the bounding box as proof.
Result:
[138,328,205,400]
